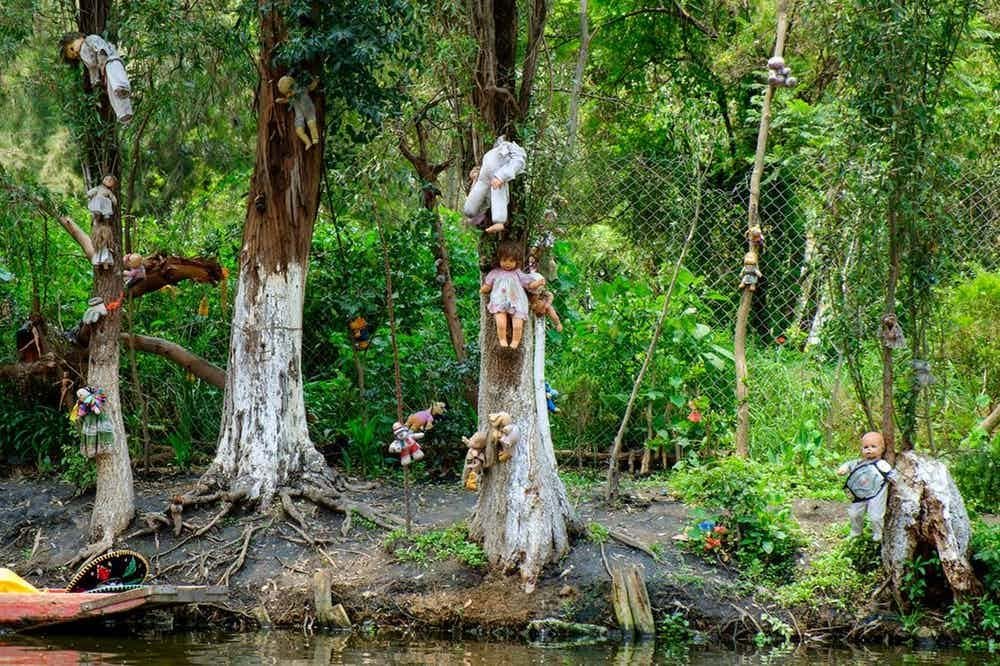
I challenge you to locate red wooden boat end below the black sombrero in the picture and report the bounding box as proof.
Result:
[0,585,228,630]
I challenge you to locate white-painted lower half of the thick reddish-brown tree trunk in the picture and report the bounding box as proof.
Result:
[207,262,330,504]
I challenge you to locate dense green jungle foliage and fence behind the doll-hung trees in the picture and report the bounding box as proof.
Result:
[0,0,1000,644]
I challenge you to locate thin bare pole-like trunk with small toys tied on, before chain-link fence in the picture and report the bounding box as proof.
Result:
[733,0,788,458]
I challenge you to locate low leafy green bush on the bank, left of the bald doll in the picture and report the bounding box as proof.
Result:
[670,457,802,578]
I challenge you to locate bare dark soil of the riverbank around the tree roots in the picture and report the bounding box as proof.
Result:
[0,476,872,637]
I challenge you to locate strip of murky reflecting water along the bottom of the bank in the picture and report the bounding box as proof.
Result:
[0,632,1000,666]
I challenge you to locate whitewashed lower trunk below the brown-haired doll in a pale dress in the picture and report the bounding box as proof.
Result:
[469,308,576,592]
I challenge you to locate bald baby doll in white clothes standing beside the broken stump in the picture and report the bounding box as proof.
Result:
[837,432,896,541]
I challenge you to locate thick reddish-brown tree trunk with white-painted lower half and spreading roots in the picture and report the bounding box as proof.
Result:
[206,4,333,505]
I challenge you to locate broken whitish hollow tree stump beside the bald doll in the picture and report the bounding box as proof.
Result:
[882,451,983,607]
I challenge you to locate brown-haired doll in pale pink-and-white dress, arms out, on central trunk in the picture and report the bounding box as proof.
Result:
[479,241,545,349]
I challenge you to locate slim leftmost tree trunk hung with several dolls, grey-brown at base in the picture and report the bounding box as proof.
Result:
[77,0,135,557]
